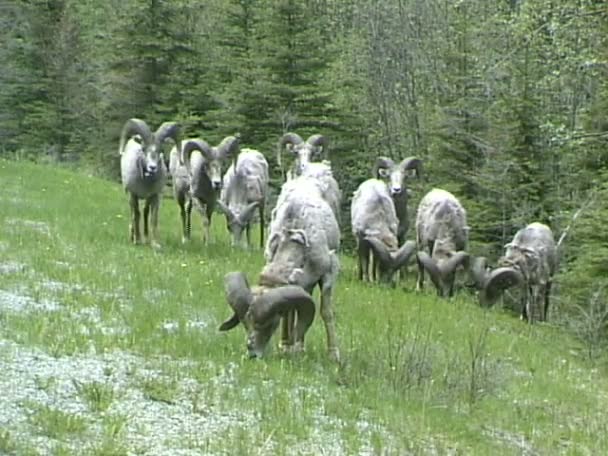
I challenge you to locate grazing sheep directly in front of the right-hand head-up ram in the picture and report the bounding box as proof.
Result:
[350,179,416,282]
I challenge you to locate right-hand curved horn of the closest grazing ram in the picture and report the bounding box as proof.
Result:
[251,285,315,340]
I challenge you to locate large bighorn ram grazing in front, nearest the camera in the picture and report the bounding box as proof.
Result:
[220,177,340,360]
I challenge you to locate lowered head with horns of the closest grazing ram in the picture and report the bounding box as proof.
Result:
[220,272,315,358]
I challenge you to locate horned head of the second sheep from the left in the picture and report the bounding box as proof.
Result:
[181,136,239,191]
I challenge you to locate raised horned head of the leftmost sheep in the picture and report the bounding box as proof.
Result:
[118,118,181,178]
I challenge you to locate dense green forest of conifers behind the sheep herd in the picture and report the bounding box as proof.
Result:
[0,0,608,330]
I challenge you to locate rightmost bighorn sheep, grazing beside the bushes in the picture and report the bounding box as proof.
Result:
[471,222,557,323]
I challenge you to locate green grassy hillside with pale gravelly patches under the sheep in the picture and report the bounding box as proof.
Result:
[0,161,608,455]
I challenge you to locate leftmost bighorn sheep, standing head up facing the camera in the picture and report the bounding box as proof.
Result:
[118,119,181,247]
